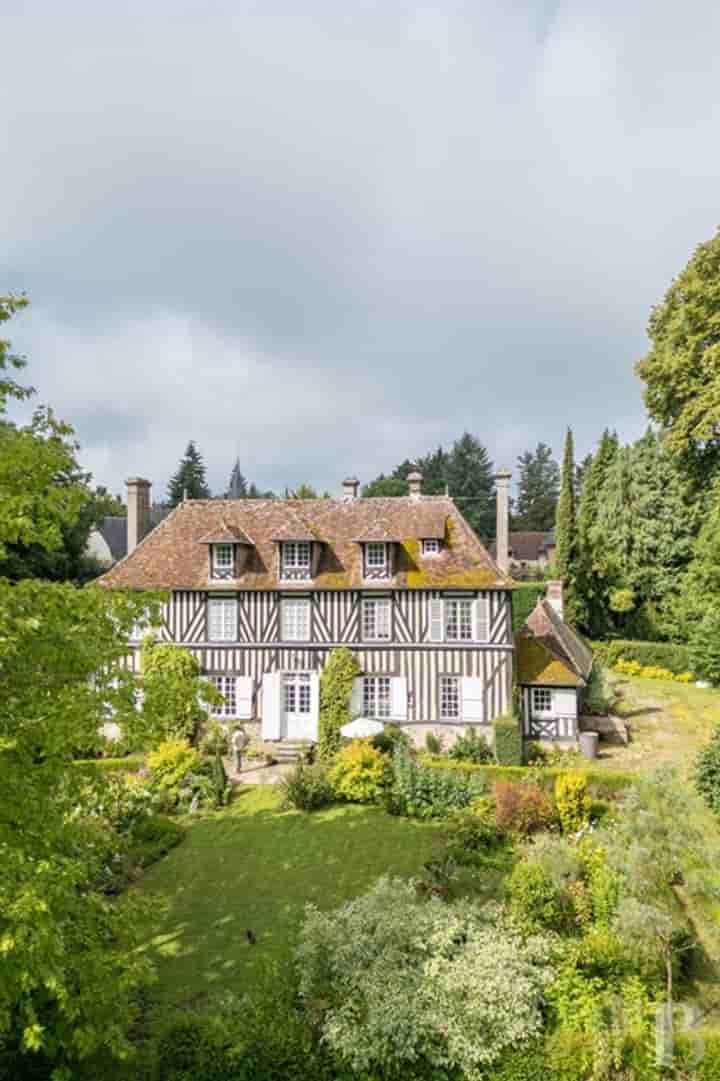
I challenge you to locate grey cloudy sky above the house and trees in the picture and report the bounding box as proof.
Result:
[0,0,720,499]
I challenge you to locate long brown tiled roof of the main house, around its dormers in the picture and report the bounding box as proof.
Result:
[98,496,512,589]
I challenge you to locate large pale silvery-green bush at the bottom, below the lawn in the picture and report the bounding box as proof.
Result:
[296,878,550,1079]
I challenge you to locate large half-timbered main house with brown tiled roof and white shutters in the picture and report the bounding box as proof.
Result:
[101,478,514,740]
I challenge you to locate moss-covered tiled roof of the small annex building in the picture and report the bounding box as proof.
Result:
[516,600,592,686]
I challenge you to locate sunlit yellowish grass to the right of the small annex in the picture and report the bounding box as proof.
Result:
[598,677,720,776]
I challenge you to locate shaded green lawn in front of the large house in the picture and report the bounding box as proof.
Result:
[134,786,510,1012]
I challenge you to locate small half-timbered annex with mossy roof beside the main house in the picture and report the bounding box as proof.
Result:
[516,582,592,744]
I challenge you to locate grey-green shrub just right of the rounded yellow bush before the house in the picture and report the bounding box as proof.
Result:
[385,746,485,818]
